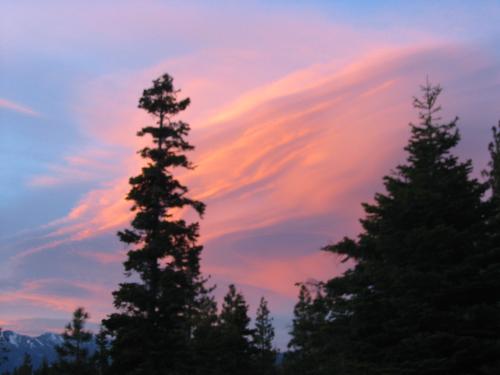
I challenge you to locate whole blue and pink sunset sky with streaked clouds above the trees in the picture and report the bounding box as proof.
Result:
[0,0,500,348]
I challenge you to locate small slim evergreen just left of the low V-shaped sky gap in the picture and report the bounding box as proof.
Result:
[253,297,276,375]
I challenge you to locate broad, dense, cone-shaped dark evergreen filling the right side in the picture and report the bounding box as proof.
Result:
[296,84,500,375]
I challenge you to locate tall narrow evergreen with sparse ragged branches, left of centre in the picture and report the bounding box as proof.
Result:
[104,74,205,375]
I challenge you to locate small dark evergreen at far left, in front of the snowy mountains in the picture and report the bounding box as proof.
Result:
[54,307,93,375]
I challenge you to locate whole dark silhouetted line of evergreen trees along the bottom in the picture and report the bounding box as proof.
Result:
[0,74,500,375]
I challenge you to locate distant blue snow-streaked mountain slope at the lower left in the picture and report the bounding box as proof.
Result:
[0,331,95,373]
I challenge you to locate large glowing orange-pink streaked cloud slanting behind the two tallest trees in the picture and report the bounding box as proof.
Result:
[47,47,496,270]
